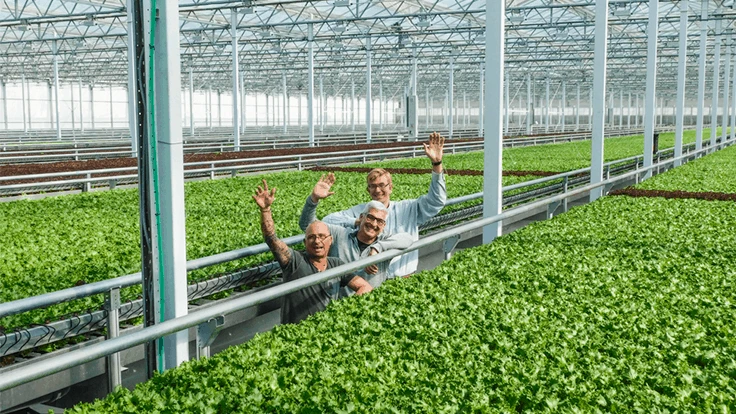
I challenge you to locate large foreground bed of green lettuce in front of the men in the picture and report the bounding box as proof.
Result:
[72,151,736,413]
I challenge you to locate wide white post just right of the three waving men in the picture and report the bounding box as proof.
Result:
[483,0,506,243]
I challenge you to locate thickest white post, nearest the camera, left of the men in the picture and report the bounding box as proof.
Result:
[149,0,187,370]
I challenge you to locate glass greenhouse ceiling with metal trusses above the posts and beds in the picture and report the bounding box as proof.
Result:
[0,0,736,94]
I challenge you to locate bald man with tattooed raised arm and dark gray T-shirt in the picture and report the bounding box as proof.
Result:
[253,180,372,323]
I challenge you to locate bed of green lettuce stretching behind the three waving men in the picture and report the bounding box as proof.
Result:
[0,131,712,330]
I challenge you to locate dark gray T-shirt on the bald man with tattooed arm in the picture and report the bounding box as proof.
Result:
[281,249,355,323]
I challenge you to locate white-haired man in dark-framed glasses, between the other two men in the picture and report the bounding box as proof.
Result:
[299,173,412,296]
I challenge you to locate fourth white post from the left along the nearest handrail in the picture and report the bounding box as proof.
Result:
[644,0,659,179]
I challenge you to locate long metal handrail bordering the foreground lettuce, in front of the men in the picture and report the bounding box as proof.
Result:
[0,141,724,391]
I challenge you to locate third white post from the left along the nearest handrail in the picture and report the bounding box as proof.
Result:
[590,0,608,202]
